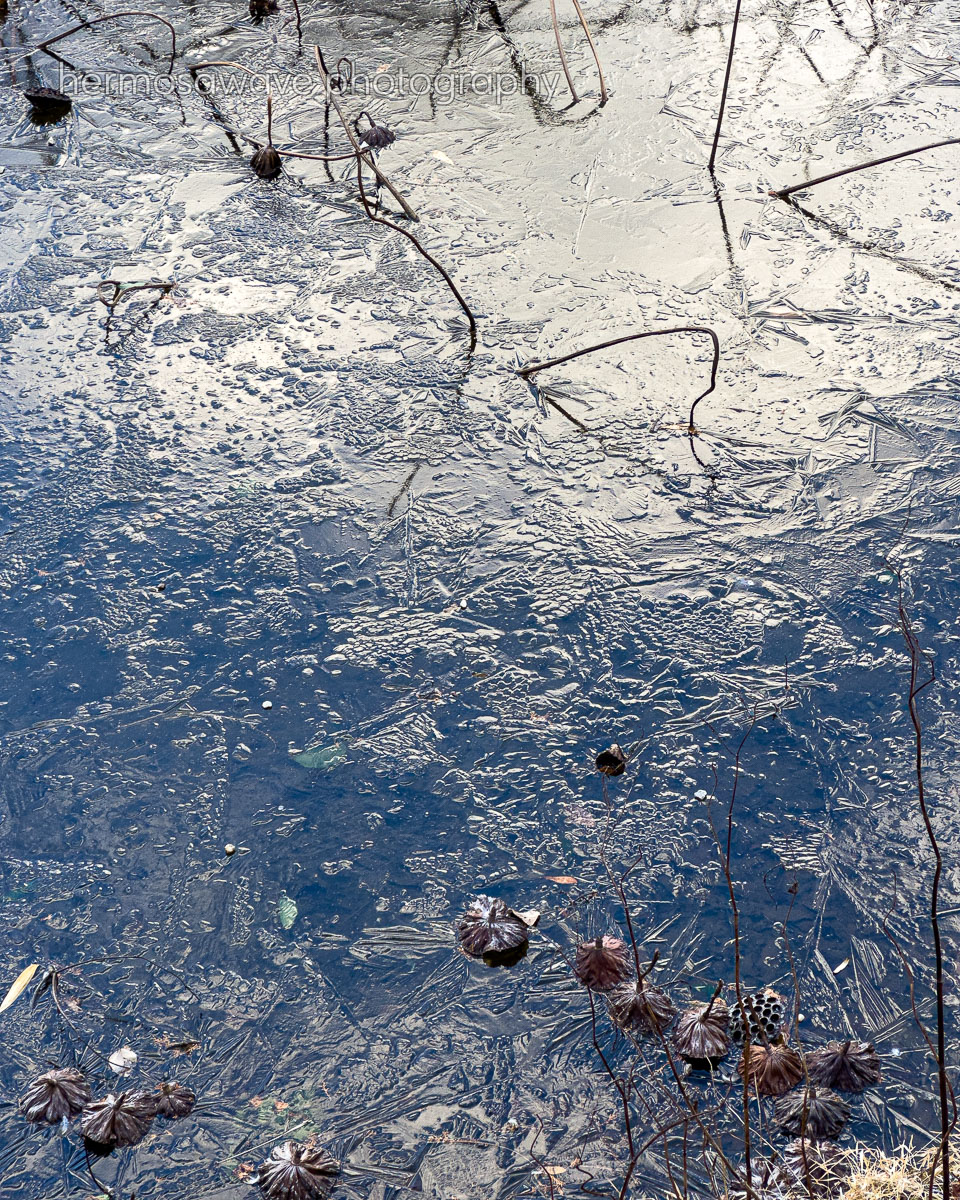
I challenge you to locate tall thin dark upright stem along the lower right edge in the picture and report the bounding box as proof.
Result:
[887,561,960,1200]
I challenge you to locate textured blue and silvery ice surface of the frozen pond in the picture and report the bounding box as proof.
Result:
[0,0,960,1200]
